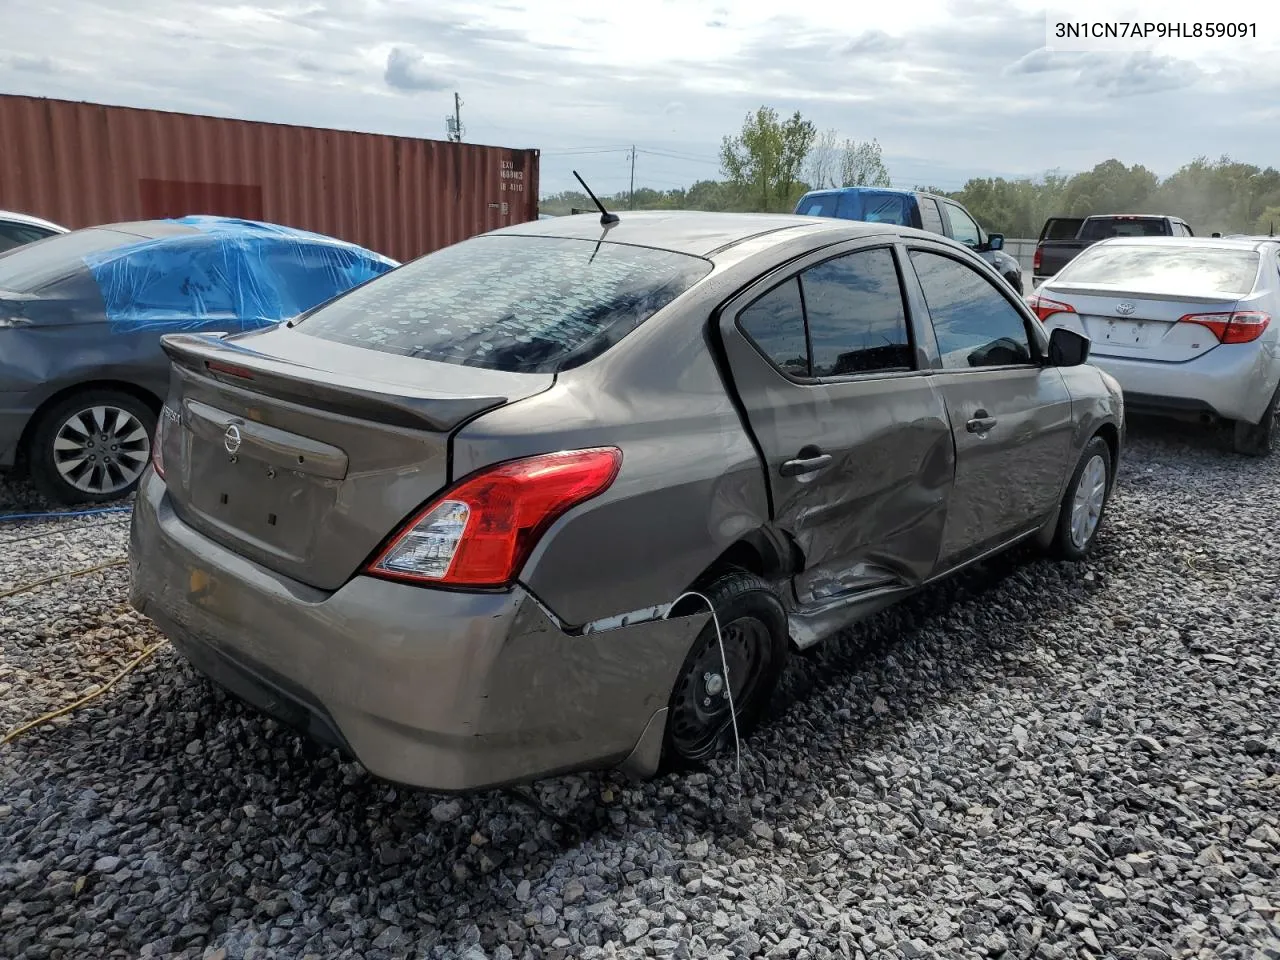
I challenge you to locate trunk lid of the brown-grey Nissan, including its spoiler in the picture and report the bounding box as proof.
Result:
[161,325,554,590]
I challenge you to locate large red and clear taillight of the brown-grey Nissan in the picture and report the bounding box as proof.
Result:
[365,447,622,588]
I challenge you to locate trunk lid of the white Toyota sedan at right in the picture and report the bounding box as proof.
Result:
[1039,285,1257,364]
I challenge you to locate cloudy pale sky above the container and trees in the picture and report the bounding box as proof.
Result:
[0,0,1280,193]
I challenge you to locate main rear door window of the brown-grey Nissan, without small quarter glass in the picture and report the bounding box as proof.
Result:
[800,247,913,376]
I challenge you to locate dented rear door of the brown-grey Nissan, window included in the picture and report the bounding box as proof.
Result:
[719,241,954,607]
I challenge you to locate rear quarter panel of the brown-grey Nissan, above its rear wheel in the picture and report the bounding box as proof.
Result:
[452,271,769,627]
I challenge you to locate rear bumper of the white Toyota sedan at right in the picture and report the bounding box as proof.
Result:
[1089,343,1280,424]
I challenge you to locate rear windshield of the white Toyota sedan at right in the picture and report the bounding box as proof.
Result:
[1055,243,1260,297]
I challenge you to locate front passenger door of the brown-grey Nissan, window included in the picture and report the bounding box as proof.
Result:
[908,243,1073,568]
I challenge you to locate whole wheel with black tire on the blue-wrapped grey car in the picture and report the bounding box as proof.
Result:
[27,388,156,506]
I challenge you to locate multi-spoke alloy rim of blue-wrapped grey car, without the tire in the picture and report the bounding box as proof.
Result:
[54,404,151,494]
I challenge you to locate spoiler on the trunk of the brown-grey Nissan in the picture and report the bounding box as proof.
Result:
[160,333,508,431]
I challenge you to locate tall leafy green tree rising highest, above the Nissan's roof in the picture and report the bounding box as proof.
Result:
[721,106,818,211]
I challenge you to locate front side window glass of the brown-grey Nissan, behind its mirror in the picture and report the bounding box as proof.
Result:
[911,250,1032,370]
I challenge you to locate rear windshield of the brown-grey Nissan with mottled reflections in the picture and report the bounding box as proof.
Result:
[298,236,712,372]
